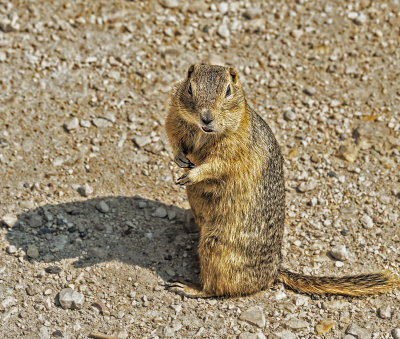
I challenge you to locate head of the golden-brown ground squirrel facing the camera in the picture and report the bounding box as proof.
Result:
[173,65,246,134]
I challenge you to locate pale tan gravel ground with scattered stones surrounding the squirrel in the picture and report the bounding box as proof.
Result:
[0,0,400,339]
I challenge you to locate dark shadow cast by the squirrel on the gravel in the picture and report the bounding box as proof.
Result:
[6,197,199,281]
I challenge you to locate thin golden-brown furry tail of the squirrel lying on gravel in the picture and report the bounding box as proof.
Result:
[278,269,400,296]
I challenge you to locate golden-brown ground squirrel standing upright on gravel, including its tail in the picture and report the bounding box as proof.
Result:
[166,65,398,297]
